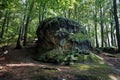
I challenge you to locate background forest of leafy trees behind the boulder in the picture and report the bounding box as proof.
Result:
[0,0,120,50]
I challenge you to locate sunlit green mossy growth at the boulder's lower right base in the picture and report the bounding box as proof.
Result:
[65,53,104,65]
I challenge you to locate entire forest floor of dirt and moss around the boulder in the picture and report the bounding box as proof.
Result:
[0,46,120,80]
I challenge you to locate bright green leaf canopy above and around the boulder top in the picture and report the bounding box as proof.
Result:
[0,0,116,48]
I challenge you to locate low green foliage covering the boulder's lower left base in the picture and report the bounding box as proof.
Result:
[34,48,65,64]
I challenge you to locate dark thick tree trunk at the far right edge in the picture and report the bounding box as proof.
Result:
[113,0,120,51]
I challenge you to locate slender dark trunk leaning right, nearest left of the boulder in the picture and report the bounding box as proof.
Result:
[23,0,34,46]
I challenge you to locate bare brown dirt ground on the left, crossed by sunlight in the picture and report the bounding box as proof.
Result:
[0,47,78,80]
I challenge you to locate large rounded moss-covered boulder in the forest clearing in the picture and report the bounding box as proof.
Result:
[35,17,91,63]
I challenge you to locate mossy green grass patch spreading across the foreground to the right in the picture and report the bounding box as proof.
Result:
[29,64,119,80]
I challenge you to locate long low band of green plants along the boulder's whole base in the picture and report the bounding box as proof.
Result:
[35,44,104,65]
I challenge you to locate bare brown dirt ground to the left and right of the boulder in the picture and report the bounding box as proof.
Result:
[0,46,120,80]
